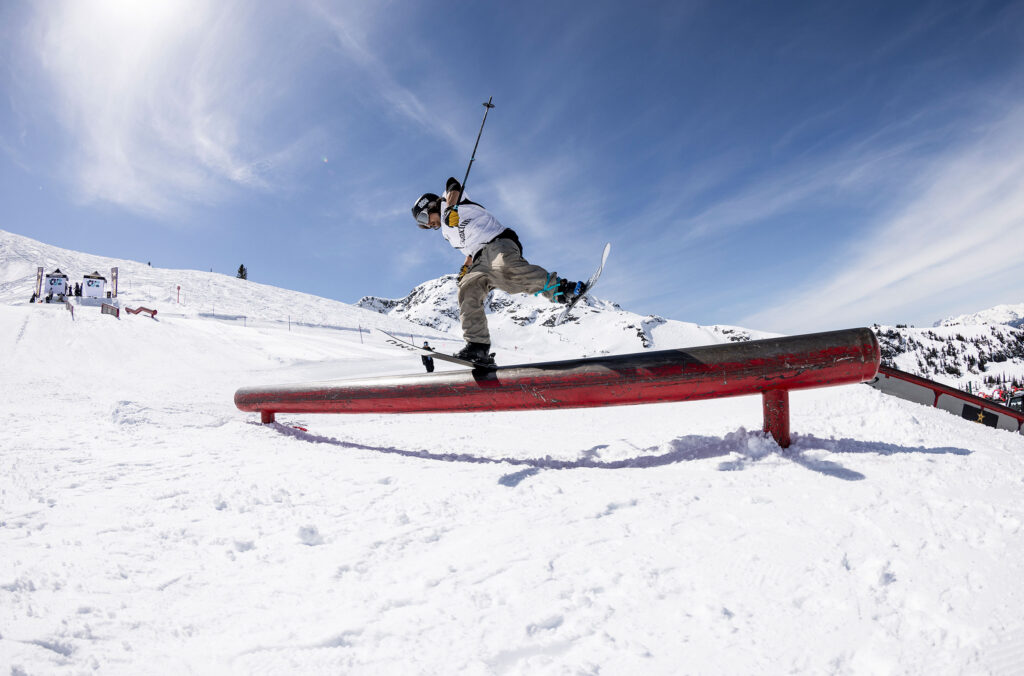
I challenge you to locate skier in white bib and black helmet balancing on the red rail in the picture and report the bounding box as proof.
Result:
[413,177,587,364]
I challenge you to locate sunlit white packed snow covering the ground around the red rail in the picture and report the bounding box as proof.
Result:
[0,229,1024,674]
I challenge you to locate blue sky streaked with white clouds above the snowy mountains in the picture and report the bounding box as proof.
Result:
[0,0,1024,333]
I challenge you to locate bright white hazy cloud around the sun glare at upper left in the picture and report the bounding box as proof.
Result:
[34,0,304,216]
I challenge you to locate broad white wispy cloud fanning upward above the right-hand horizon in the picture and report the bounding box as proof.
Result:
[741,105,1024,332]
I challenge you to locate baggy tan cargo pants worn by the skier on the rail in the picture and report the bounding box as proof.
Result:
[459,240,555,345]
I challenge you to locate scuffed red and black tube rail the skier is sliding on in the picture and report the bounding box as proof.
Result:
[234,329,880,448]
